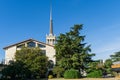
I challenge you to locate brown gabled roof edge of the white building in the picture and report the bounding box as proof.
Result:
[3,38,54,49]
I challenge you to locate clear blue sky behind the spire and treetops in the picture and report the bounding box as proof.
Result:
[0,0,120,61]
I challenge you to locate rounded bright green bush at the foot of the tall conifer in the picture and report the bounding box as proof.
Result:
[64,69,80,79]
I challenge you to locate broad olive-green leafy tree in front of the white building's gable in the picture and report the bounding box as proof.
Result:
[15,47,48,78]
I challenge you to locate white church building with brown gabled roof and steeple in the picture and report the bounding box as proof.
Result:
[3,7,56,64]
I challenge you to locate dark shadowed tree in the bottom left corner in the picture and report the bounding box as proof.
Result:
[2,61,27,80]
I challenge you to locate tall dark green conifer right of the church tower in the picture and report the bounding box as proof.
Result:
[55,24,94,74]
